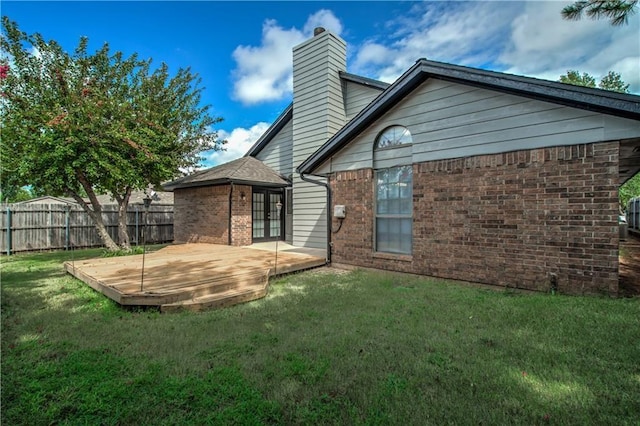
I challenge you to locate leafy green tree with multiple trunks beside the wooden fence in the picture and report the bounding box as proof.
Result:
[0,16,224,250]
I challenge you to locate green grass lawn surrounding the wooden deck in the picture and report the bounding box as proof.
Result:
[1,250,640,425]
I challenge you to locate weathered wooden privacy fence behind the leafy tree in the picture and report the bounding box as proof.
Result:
[0,204,173,254]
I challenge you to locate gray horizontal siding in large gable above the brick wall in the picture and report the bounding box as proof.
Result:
[316,79,640,174]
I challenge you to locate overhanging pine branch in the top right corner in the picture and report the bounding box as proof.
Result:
[562,0,638,26]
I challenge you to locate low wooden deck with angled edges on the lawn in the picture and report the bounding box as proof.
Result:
[64,244,325,312]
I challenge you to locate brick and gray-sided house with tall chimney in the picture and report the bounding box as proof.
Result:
[166,29,640,294]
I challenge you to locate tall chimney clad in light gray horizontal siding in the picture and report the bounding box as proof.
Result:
[293,31,347,249]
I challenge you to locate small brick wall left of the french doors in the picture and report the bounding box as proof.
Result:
[174,185,251,246]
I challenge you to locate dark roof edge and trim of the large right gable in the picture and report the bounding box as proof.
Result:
[296,59,640,174]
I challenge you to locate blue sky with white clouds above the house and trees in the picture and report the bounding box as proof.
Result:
[2,1,640,166]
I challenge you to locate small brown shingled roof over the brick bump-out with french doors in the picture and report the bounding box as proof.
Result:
[162,157,289,191]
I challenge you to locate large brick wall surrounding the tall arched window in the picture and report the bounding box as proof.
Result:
[330,142,619,295]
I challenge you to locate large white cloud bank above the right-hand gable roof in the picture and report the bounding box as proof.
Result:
[350,1,640,93]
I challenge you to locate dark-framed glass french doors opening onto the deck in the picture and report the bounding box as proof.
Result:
[252,188,285,243]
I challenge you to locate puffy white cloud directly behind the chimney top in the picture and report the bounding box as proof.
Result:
[233,9,342,104]
